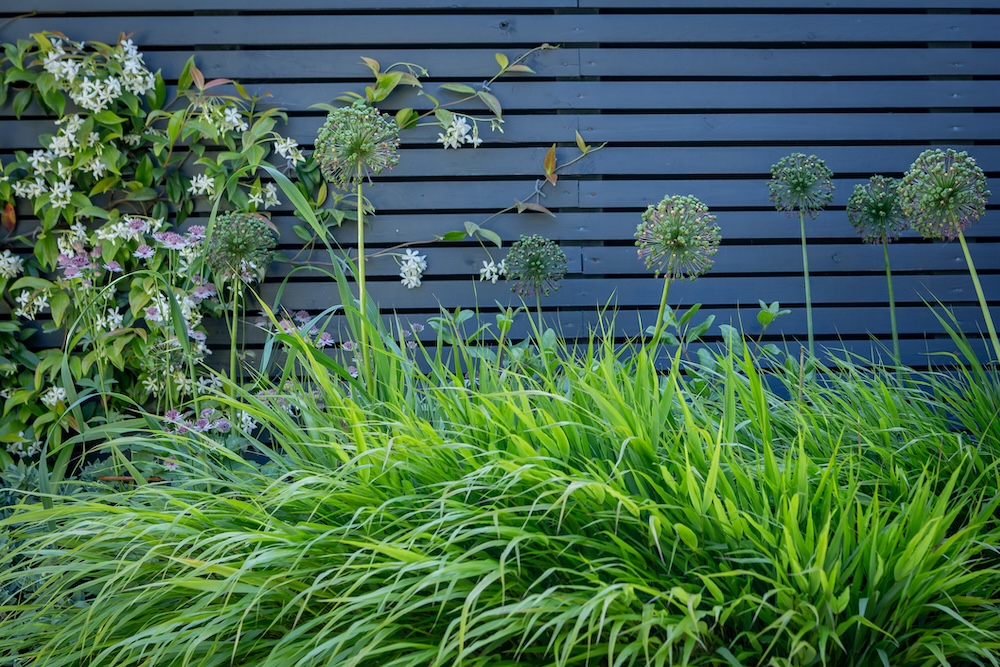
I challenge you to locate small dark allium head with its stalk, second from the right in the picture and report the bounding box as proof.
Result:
[847,176,910,366]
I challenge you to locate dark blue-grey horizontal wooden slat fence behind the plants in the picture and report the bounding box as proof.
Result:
[0,0,1000,365]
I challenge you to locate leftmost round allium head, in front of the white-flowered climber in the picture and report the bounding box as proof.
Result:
[205,211,275,283]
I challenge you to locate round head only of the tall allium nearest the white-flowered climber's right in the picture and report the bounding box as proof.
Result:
[315,100,399,189]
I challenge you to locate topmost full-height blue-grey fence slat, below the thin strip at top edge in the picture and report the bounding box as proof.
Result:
[0,13,1000,47]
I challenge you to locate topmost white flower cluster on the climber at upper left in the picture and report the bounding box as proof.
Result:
[42,39,156,113]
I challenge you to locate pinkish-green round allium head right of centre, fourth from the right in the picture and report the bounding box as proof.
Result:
[635,195,722,280]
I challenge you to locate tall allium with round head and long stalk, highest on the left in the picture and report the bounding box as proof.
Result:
[315,100,399,372]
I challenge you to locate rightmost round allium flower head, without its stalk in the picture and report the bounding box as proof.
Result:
[899,148,990,240]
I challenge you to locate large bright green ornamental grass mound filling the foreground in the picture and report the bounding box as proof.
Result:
[0,314,1000,667]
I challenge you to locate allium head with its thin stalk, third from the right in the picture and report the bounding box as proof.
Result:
[767,153,833,355]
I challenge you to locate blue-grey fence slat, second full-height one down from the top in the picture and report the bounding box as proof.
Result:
[117,46,1000,81]
